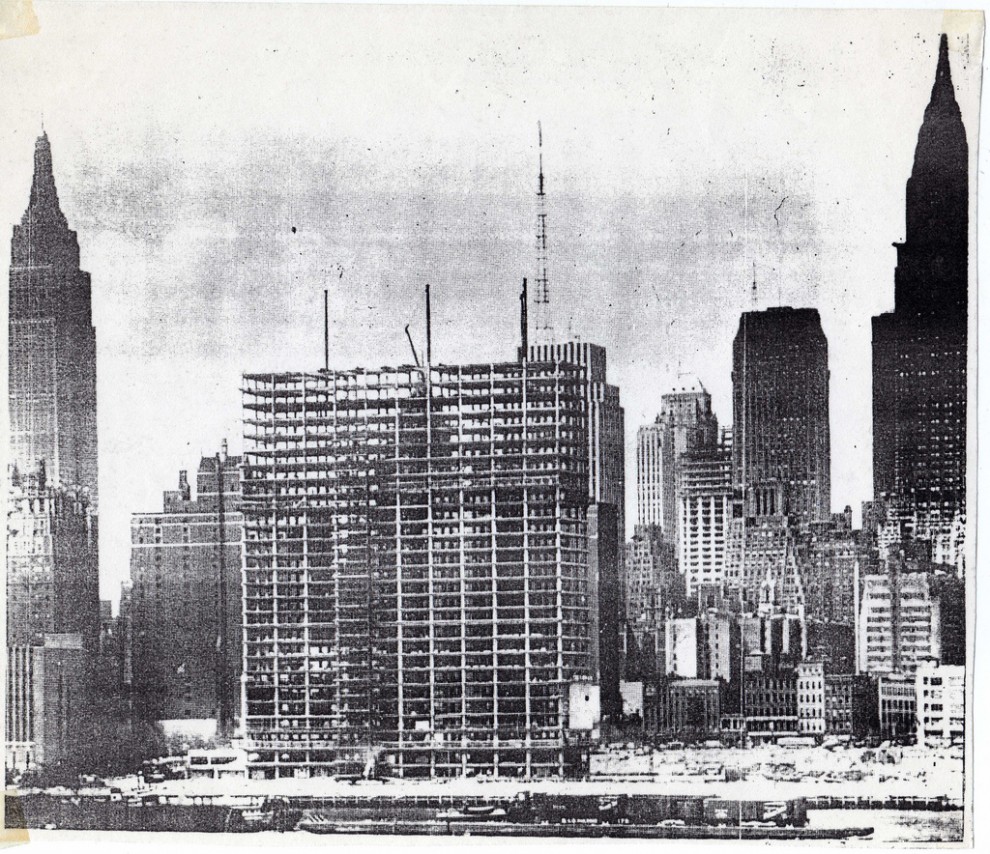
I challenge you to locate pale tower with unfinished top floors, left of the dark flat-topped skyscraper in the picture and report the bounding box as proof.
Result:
[677,431,733,597]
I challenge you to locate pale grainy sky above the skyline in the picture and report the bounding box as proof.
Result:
[0,3,982,598]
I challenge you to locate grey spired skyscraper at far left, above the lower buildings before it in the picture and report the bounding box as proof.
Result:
[9,133,97,504]
